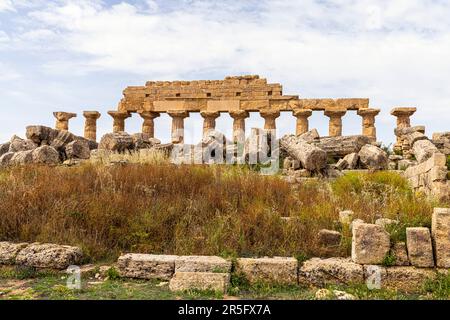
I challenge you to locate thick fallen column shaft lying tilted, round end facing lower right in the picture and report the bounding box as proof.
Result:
[280,135,327,171]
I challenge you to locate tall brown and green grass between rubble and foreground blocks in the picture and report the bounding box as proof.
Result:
[0,162,448,261]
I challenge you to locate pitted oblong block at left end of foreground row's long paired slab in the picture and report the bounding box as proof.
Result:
[117,253,178,280]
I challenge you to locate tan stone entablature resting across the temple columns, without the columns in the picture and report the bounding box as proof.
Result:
[118,75,369,112]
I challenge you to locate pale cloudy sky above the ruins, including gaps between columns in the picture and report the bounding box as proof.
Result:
[0,0,450,144]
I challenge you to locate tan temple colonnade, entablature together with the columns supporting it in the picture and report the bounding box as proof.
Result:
[108,75,379,142]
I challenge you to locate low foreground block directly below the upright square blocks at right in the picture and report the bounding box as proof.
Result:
[364,266,436,293]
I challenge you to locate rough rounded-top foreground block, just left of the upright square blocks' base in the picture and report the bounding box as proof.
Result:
[299,258,364,287]
